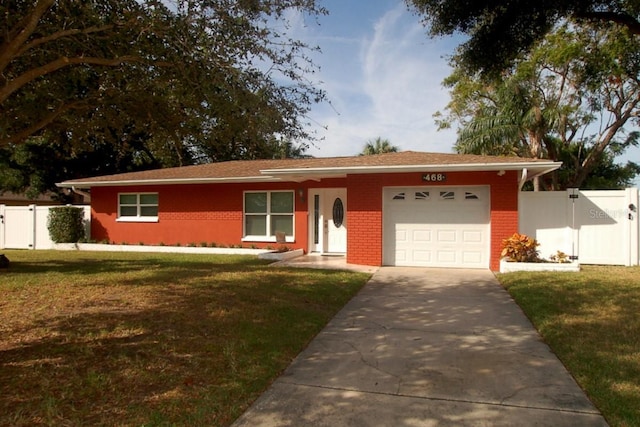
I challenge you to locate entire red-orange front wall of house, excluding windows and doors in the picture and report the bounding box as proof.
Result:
[91,171,518,270]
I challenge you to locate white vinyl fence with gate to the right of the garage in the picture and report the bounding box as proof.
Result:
[518,188,640,266]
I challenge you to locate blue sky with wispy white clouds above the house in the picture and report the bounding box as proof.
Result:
[284,0,640,186]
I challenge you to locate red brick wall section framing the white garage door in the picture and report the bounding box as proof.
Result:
[347,171,518,270]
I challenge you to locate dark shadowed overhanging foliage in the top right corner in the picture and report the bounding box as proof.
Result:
[406,0,640,76]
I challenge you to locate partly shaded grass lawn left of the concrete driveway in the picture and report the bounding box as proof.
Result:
[0,251,369,426]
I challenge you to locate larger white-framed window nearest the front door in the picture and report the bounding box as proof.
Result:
[244,191,294,241]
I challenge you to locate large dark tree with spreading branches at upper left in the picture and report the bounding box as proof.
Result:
[0,0,324,166]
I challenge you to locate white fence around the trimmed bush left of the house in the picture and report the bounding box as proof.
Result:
[0,205,91,249]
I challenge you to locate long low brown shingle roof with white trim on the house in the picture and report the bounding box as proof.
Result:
[58,151,559,187]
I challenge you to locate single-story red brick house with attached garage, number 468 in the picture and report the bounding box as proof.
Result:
[58,151,560,270]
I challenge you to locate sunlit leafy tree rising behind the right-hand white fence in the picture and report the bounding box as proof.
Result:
[438,25,640,189]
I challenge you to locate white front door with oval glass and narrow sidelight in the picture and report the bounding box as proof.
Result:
[309,188,347,254]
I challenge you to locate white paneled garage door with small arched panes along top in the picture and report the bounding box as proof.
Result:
[383,187,490,268]
